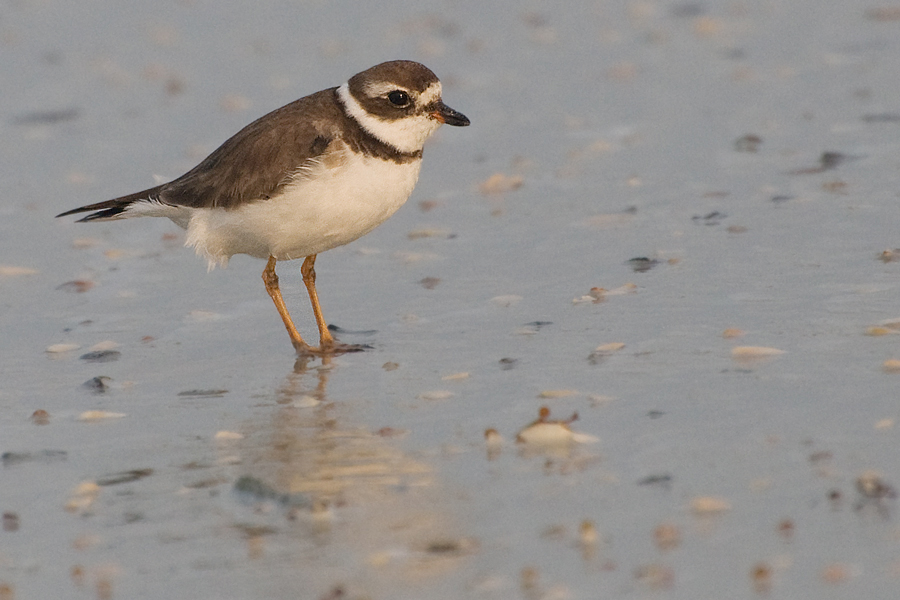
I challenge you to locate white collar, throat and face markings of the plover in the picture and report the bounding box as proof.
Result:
[338,83,441,153]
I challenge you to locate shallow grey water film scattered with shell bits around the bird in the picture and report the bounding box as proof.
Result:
[0,0,900,600]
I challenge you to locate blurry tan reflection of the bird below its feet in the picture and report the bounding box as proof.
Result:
[232,357,474,591]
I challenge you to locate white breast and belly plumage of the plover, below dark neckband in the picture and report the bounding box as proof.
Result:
[184,153,422,268]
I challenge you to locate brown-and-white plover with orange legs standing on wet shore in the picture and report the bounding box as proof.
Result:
[57,60,470,356]
